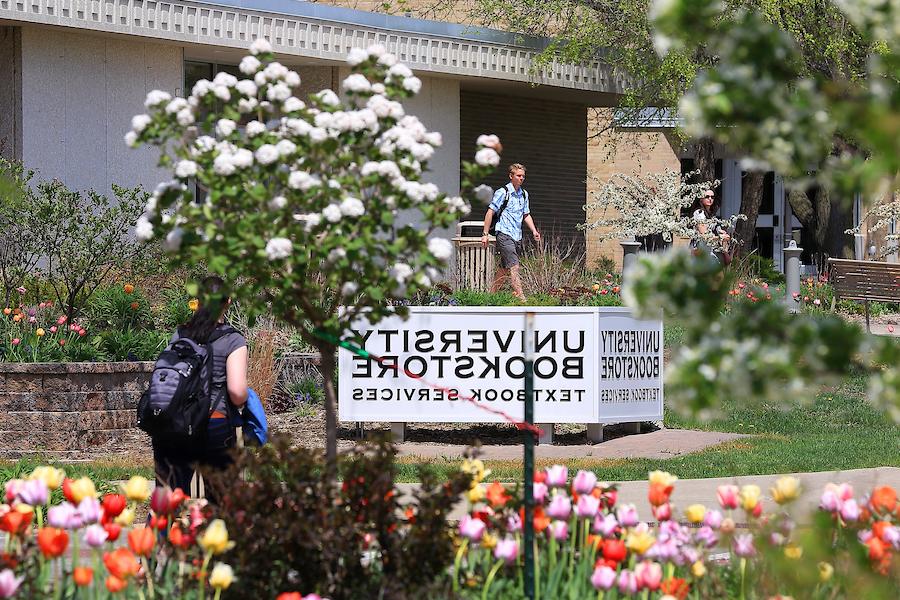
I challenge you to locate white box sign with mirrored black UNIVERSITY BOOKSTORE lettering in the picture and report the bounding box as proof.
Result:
[338,306,663,423]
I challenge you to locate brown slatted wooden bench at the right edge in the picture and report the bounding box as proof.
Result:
[828,258,900,333]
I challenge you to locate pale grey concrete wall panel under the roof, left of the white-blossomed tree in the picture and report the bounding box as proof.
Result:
[22,27,183,194]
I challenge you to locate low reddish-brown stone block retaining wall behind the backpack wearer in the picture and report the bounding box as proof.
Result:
[0,354,318,458]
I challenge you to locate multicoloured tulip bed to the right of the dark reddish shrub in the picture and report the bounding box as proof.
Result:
[451,460,900,600]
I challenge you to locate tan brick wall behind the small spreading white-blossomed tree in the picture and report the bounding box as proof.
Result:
[586,115,681,268]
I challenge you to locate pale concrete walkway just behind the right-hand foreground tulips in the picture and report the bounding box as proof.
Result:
[398,467,900,520]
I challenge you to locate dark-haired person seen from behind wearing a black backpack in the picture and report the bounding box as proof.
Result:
[138,277,248,496]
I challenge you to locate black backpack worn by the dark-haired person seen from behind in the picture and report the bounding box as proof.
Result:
[137,326,236,445]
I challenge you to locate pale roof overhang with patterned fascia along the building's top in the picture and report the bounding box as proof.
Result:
[0,0,626,104]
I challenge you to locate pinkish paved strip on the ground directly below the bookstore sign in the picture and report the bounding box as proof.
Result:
[397,429,746,460]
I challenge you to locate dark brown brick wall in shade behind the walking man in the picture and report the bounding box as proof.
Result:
[459,90,587,249]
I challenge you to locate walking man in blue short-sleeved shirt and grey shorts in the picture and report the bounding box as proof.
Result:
[481,163,541,302]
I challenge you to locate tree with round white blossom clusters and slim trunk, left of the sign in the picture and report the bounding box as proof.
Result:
[125,39,500,464]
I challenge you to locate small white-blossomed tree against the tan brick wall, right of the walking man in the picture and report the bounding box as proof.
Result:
[579,169,743,250]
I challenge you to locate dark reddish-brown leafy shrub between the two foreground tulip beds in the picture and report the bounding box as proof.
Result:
[204,436,470,600]
